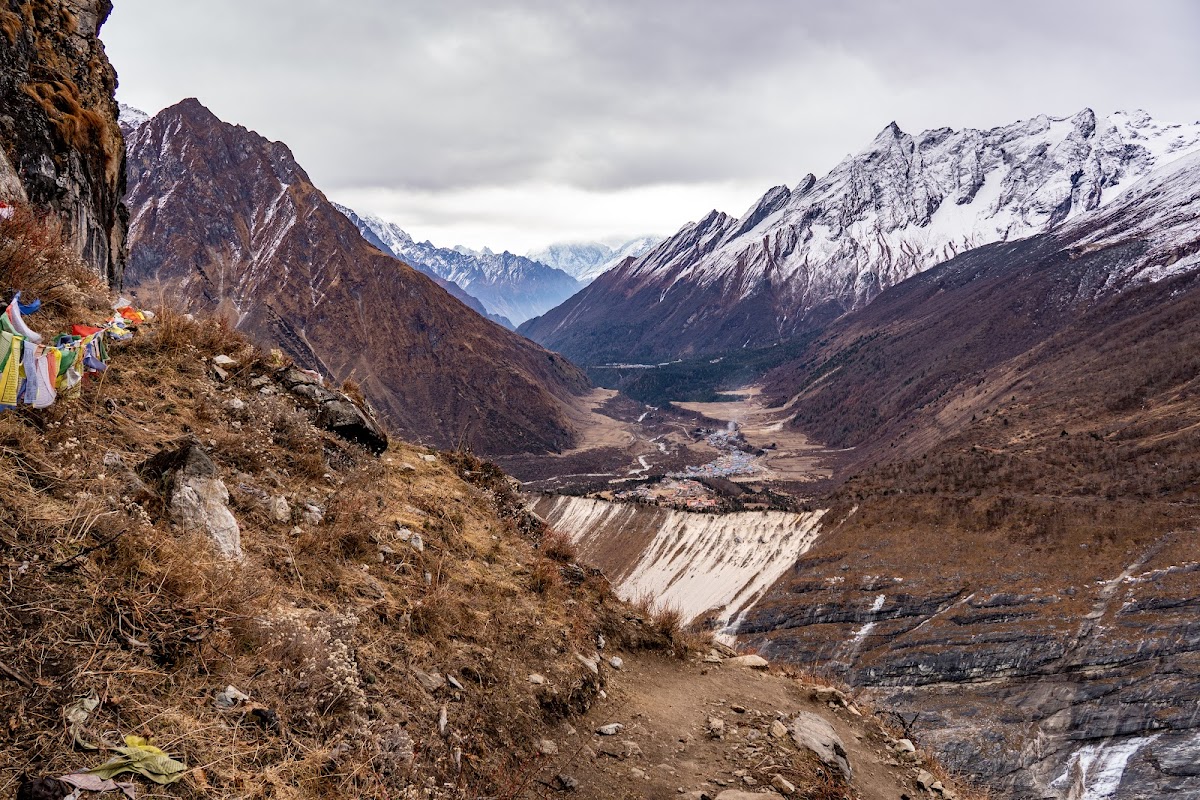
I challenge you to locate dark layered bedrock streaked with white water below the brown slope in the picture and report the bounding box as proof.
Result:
[737,540,1200,800]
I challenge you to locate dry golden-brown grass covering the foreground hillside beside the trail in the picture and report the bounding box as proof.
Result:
[0,241,700,798]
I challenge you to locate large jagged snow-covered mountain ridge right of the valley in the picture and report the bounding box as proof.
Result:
[522,109,1200,363]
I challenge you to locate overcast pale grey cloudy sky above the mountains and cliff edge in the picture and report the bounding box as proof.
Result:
[101,0,1200,253]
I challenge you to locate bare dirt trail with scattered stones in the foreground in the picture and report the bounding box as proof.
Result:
[527,655,935,800]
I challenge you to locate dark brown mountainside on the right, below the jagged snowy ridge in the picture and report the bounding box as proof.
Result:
[739,154,1200,798]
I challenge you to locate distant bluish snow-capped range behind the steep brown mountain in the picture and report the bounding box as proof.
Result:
[337,206,583,325]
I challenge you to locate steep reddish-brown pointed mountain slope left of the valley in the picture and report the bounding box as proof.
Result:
[126,100,587,453]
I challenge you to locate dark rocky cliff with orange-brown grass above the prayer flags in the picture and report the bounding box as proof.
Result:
[0,0,126,285]
